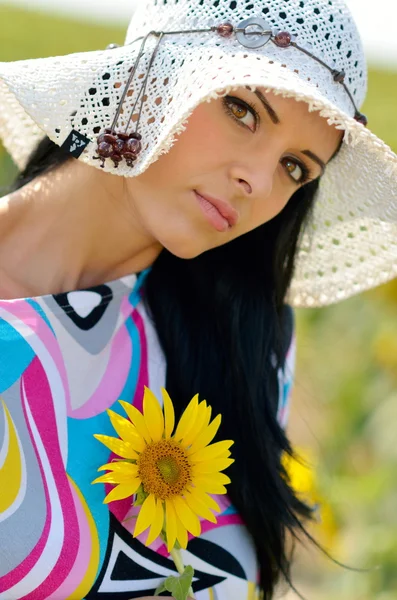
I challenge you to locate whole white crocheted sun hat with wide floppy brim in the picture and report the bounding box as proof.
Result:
[0,0,397,307]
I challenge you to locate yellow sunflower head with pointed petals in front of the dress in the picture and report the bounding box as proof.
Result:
[93,388,234,552]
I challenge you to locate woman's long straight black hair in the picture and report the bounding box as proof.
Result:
[11,138,318,600]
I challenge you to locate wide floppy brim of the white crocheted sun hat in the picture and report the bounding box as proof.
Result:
[0,35,397,307]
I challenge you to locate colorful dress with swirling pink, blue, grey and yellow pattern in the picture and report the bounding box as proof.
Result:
[0,273,294,600]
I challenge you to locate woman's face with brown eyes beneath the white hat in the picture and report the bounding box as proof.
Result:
[127,88,343,258]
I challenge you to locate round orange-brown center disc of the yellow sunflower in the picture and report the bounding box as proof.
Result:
[137,440,192,499]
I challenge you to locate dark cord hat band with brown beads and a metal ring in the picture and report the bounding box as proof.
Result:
[93,17,368,168]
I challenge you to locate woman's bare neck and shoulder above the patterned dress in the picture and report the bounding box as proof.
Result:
[0,159,161,299]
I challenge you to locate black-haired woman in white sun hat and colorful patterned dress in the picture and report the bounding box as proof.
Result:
[0,0,397,600]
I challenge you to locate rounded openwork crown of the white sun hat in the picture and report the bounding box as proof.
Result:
[125,0,367,116]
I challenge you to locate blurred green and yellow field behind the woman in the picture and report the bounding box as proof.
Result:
[0,5,397,600]
